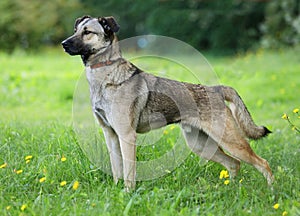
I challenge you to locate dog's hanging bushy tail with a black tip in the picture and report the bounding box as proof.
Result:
[222,86,271,139]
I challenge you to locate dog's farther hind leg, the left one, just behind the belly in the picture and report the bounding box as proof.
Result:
[182,126,240,177]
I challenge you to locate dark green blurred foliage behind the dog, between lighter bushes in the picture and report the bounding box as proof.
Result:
[85,0,265,50]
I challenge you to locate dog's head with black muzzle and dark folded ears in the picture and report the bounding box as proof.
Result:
[62,16,119,62]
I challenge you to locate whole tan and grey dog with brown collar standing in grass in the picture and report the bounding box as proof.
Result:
[62,16,273,190]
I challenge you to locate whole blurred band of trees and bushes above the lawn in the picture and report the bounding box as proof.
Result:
[0,0,300,52]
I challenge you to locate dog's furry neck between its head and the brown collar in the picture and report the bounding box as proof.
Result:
[82,36,122,68]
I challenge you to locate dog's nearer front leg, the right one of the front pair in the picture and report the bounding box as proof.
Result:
[119,131,136,192]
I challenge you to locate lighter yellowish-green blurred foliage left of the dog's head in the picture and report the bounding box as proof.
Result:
[0,0,80,51]
